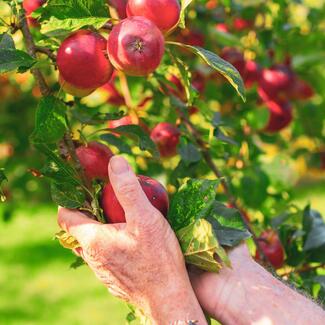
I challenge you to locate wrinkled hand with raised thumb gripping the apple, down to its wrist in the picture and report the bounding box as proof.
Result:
[58,157,206,324]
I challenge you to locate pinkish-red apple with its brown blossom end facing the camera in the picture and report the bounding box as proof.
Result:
[107,17,165,76]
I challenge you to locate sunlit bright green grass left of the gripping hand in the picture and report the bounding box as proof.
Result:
[0,206,128,325]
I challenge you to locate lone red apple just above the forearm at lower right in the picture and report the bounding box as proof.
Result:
[255,230,284,269]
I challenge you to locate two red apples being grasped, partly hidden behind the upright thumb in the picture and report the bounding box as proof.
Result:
[76,142,169,223]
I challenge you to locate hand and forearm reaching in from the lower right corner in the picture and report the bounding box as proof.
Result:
[190,244,325,325]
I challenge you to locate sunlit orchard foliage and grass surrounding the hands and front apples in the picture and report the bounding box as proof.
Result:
[0,0,325,324]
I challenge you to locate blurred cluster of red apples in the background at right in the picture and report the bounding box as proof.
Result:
[221,48,314,133]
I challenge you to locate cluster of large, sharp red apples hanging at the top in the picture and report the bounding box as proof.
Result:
[57,0,180,97]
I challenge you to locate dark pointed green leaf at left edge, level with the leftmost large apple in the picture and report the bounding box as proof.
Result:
[0,48,36,73]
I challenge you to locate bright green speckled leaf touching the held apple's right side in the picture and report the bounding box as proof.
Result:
[168,179,220,231]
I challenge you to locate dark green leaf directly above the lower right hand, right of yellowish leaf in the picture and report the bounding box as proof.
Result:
[207,201,251,247]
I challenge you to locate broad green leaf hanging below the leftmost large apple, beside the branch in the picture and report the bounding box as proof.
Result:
[31,96,67,143]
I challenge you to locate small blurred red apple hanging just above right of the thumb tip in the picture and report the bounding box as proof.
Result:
[150,122,180,158]
